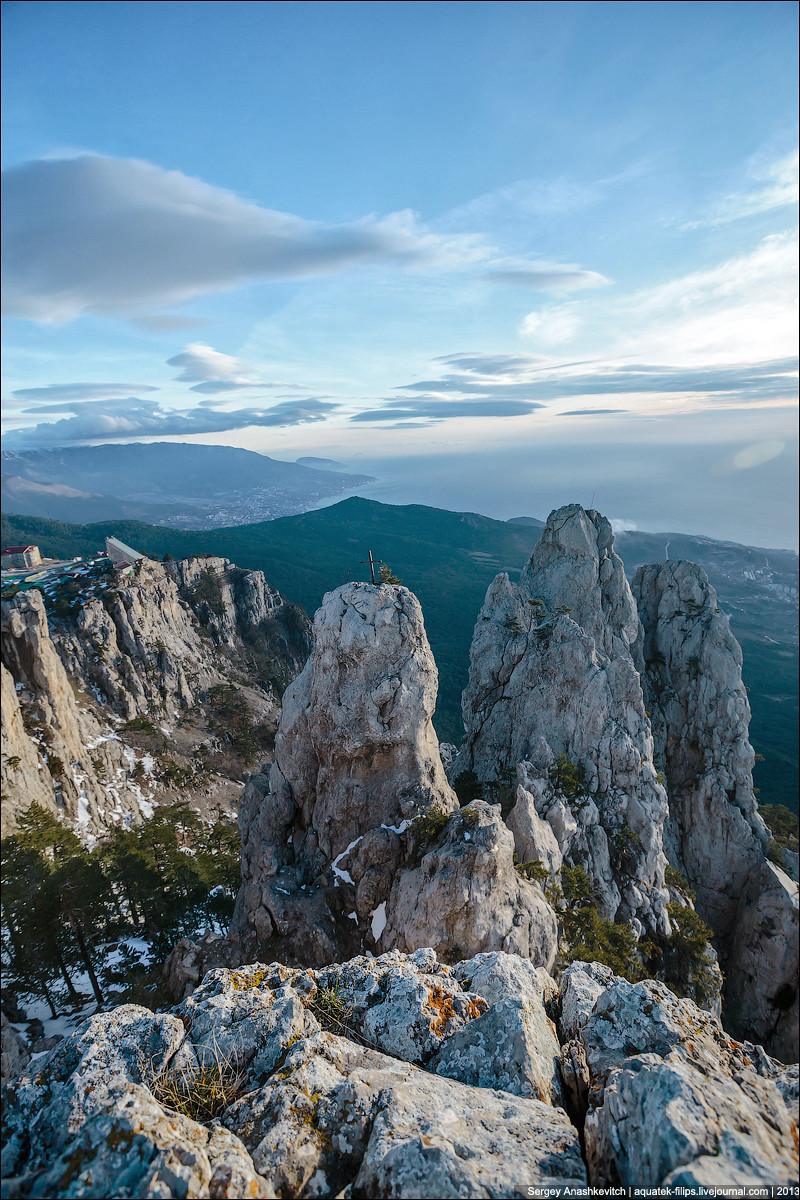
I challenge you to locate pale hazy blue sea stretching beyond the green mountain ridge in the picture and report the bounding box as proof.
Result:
[317,436,798,550]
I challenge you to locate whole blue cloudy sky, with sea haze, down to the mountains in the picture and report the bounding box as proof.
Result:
[2,0,798,546]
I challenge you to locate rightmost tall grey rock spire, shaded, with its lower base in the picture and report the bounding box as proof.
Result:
[633,562,798,1061]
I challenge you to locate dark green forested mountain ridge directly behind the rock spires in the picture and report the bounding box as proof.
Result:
[2,492,798,810]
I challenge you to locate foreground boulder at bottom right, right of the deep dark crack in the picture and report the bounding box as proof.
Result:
[561,964,798,1188]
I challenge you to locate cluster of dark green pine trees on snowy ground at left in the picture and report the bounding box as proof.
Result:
[1,803,240,1016]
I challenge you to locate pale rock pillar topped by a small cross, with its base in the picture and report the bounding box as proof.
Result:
[227,583,558,967]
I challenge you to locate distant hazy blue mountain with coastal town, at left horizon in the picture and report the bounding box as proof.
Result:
[1,442,373,529]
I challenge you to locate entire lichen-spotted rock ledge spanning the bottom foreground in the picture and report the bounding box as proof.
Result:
[2,949,798,1200]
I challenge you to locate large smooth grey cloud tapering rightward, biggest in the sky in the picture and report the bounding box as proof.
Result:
[4,155,486,322]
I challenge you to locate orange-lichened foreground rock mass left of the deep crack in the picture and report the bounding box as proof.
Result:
[2,950,585,1200]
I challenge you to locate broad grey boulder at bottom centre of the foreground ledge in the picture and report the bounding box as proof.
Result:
[227,1033,585,1198]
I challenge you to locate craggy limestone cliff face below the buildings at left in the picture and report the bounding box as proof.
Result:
[2,558,309,840]
